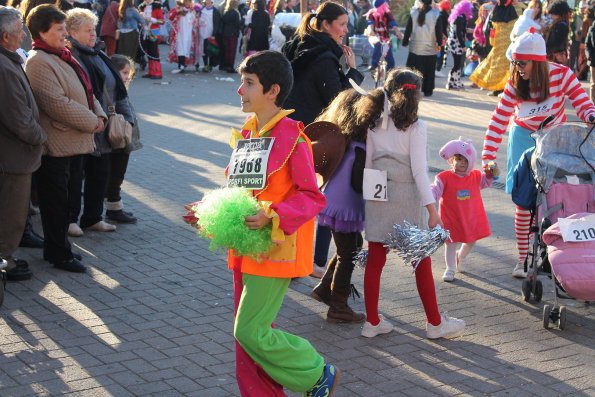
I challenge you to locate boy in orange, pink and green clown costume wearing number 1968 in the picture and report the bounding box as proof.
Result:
[228,51,339,397]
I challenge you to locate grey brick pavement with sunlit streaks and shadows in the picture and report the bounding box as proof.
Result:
[0,47,595,397]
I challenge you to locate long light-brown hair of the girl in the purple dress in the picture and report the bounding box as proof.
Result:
[316,88,370,142]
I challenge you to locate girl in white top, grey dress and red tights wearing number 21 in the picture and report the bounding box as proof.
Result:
[357,69,465,339]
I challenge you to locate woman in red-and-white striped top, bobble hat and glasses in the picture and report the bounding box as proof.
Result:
[481,28,595,278]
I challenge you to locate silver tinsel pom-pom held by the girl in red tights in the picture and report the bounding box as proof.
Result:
[353,221,450,272]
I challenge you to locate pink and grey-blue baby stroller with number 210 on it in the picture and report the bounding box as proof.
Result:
[522,123,595,329]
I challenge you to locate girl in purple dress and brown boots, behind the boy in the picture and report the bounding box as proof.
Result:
[308,89,368,323]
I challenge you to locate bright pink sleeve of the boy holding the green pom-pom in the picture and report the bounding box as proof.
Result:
[271,142,326,234]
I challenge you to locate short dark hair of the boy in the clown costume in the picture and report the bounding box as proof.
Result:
[238,51,293,107]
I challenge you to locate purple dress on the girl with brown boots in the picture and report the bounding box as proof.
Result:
[318,142,366,233]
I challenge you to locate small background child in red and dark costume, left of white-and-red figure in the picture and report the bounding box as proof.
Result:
[138,0,165,80]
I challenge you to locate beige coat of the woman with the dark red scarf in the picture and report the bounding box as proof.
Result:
[25,50,107,157]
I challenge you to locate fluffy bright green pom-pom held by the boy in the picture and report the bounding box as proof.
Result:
[195,187,273,258]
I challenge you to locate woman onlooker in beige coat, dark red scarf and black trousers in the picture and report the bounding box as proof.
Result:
[25,4,107,273]
